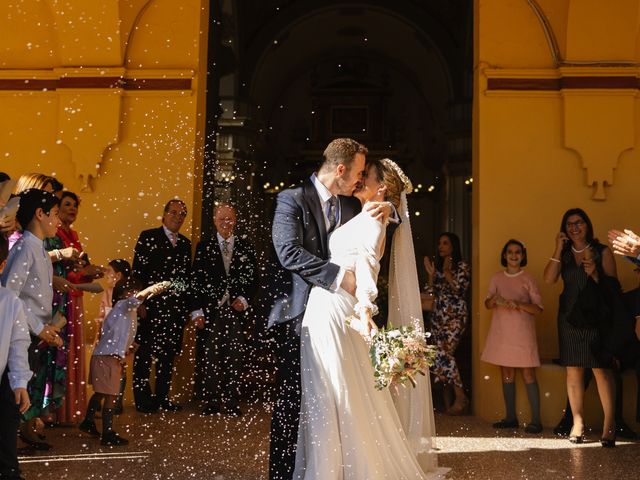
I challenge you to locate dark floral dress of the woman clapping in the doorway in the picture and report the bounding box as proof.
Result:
[431,261,471,388]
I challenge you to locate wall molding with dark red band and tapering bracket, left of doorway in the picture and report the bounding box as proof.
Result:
[0,67,195,191]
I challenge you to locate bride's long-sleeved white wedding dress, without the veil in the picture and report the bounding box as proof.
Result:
[293,212,438,480]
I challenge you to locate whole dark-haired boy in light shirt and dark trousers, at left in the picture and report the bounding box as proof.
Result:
[1,188,62,449]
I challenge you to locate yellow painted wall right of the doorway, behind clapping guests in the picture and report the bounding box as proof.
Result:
[472,0,640,428]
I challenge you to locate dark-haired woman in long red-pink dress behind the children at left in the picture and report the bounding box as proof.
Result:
[56,191,104,423]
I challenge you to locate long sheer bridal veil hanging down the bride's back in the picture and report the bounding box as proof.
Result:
[389,187,438,472]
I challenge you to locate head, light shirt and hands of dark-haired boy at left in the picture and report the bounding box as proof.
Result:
[0,188,62,346]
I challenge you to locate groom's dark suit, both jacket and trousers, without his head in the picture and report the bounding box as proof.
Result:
[269,179,362,480]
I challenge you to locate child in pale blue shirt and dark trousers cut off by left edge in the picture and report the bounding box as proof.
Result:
[0,287,32,479]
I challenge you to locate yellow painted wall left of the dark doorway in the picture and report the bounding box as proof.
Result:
[0,0,208,402]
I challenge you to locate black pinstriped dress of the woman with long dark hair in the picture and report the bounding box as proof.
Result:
[558,243,608,368]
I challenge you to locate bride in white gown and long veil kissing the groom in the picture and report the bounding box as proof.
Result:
[293,159,442,480]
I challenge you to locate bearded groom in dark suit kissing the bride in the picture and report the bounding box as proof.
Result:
[269,138,378,480]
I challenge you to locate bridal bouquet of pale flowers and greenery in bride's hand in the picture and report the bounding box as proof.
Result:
[369,325,436,390]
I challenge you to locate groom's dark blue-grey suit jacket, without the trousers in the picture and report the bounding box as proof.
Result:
[269,179,362,327]
